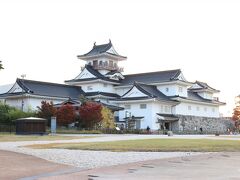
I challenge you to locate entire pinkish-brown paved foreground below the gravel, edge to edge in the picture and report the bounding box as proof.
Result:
[0,151,240,180]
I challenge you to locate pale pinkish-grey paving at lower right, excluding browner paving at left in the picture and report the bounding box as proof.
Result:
[39,153,240,180]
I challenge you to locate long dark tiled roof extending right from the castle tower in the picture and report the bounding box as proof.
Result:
[120,69,181,86]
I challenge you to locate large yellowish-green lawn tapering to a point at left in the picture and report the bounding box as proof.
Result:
[28,139,240,152]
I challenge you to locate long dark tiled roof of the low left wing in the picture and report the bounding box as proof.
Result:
[16,79,84,99]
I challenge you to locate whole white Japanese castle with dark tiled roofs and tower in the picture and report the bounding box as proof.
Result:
[0,41,225,129]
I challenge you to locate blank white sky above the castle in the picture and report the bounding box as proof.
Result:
[0,0,240,115]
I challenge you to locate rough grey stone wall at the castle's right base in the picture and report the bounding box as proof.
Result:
[172,115,234,134]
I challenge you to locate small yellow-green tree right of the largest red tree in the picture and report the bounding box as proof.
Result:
[101,106,115,129]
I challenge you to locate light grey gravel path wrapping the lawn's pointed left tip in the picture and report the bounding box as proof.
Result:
[0,135,210,169]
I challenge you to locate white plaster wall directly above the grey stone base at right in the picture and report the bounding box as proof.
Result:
[173,103,219,117]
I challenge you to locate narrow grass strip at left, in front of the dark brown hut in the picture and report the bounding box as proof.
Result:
[0,134,93,142]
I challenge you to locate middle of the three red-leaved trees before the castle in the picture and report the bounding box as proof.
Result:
[57,104,76,126]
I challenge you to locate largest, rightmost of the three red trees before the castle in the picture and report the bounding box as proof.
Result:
[79,102,102,128]
